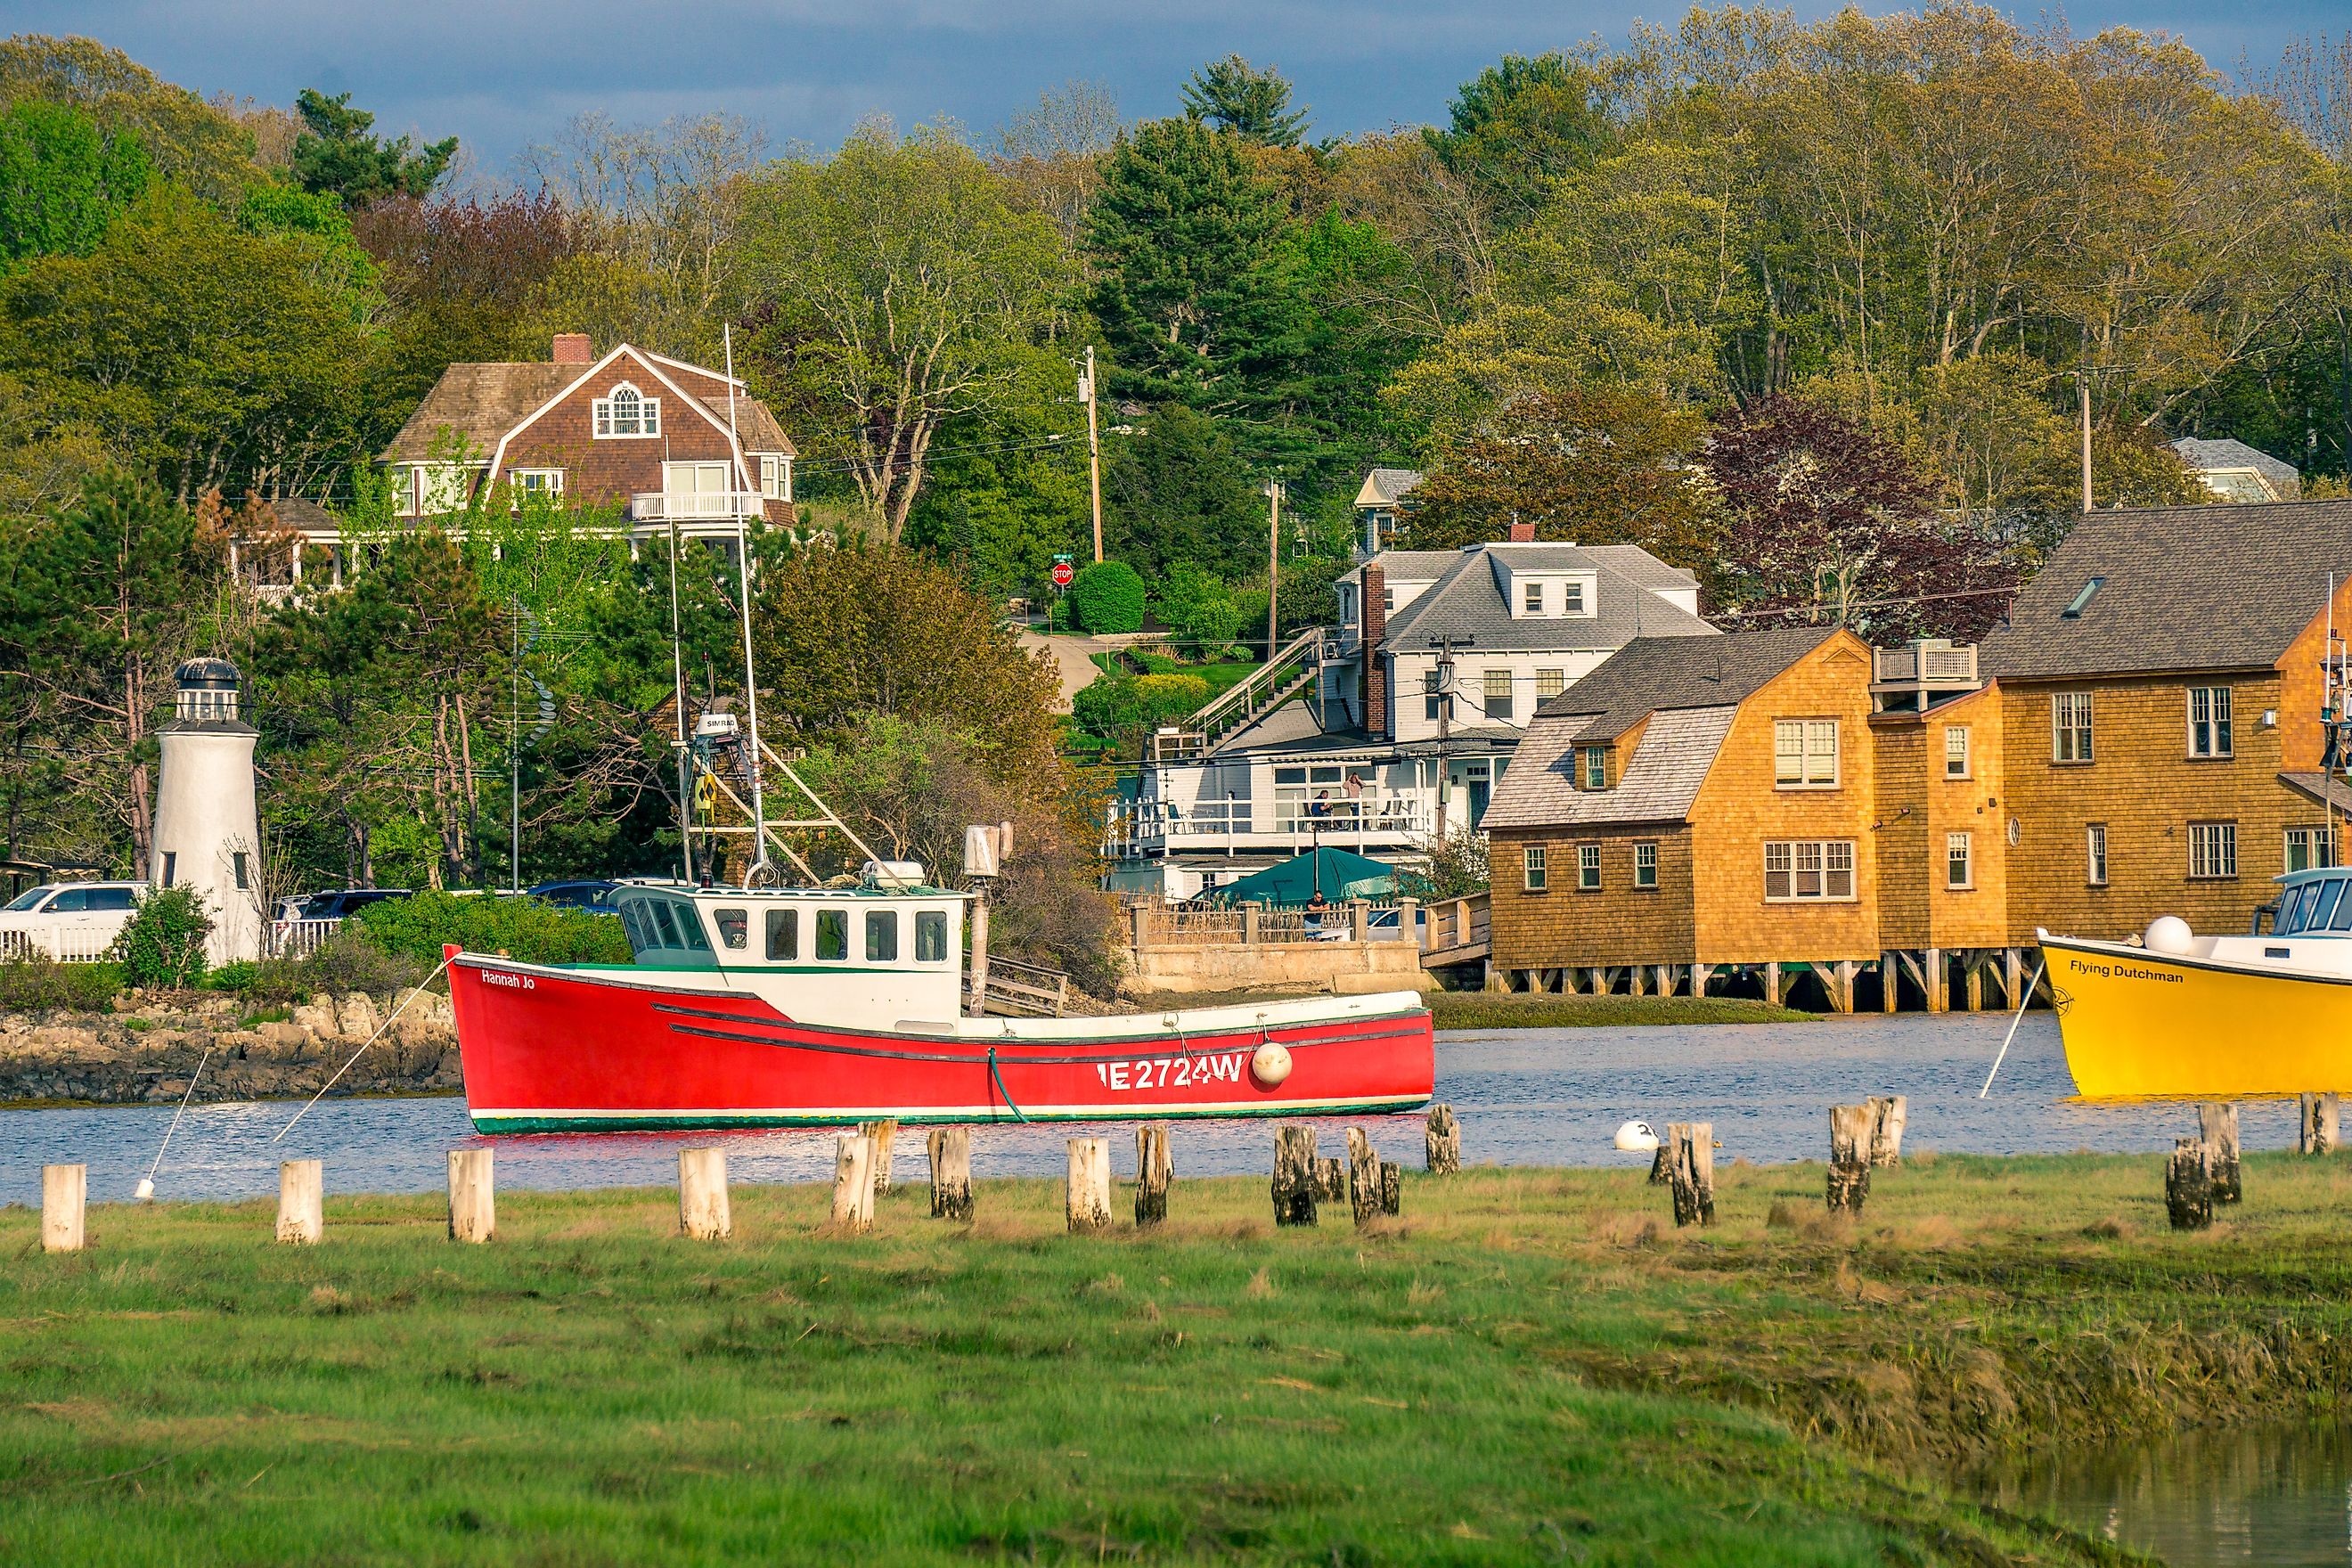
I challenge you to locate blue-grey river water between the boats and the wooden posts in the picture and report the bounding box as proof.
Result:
[0,1013,2296,1204]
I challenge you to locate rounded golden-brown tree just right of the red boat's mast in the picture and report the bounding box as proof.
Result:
[753,548,1061,780]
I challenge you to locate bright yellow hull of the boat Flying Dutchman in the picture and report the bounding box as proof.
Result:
[2042,934,2352,1100]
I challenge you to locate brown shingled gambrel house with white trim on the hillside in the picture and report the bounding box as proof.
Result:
[381,334,795,536]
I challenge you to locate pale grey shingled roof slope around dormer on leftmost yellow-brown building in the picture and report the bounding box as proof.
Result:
[1480,709,1738,829]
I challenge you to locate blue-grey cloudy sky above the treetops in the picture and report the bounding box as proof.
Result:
[22,0,2352,176]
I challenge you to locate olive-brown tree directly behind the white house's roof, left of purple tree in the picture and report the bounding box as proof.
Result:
[1404,386,1715,571]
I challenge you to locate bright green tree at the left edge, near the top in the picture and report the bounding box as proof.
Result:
[0,99,153,268]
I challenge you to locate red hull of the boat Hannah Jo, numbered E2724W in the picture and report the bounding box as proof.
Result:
[449,954,1434,1133]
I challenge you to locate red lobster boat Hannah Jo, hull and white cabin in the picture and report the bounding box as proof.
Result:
[449,882,1434,1133]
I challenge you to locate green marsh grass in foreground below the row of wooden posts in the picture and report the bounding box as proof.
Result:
[0,1147,2352,1565]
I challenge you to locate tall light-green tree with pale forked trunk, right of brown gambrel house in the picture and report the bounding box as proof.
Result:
[750,122,1077,545]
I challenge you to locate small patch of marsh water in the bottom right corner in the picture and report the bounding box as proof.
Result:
[1973,1427,2352,1568]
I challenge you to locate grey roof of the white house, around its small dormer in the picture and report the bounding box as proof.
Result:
[1385,545,1719,651]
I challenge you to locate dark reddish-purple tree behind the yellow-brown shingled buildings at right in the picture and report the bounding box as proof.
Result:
[1703,395,2018,641]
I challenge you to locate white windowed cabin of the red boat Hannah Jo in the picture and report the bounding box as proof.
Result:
[614,884,971,1020]
